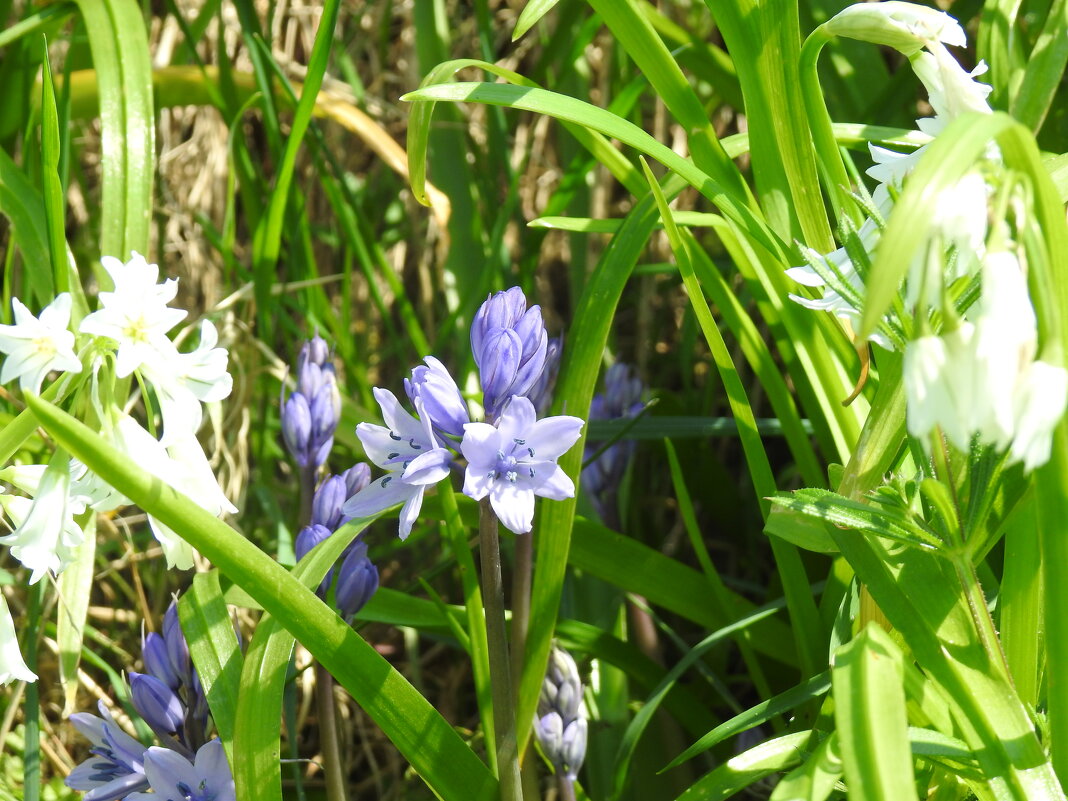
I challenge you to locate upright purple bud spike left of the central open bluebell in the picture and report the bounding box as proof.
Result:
[282,335,341,469]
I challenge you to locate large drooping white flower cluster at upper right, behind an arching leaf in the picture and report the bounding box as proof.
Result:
[788,2,1068,470]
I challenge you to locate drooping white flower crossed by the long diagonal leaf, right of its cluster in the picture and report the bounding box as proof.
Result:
[115,415,237,570]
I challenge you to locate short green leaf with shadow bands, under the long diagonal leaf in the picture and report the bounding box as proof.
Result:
[178,570,244,766]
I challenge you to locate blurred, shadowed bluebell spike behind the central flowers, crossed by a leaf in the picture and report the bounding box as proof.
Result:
[582,362,645,520]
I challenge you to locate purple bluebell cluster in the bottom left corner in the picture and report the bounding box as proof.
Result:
[65,603,235,801]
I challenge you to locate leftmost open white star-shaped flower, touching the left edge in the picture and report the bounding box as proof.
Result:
[0,293,81,393]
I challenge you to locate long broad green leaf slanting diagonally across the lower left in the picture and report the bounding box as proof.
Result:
[30,398,497,801]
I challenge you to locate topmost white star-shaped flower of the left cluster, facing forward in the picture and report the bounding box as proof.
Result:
[79,253,186,378]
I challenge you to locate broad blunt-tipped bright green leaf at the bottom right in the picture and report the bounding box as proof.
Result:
[832,624,916,801]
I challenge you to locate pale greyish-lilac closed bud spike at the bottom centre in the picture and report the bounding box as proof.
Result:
[534,645,587,791]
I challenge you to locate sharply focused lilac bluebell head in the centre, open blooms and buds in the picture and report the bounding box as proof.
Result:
[344,287,582,538]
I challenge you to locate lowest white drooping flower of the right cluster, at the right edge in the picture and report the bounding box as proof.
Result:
[1009,361,1068,472]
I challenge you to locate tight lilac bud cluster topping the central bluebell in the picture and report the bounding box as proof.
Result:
[471,286,549,421]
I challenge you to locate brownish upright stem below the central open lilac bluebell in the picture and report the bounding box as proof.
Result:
[478,499,523,801]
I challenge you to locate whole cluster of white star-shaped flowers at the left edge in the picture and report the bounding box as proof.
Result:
[0,253,237,680]
